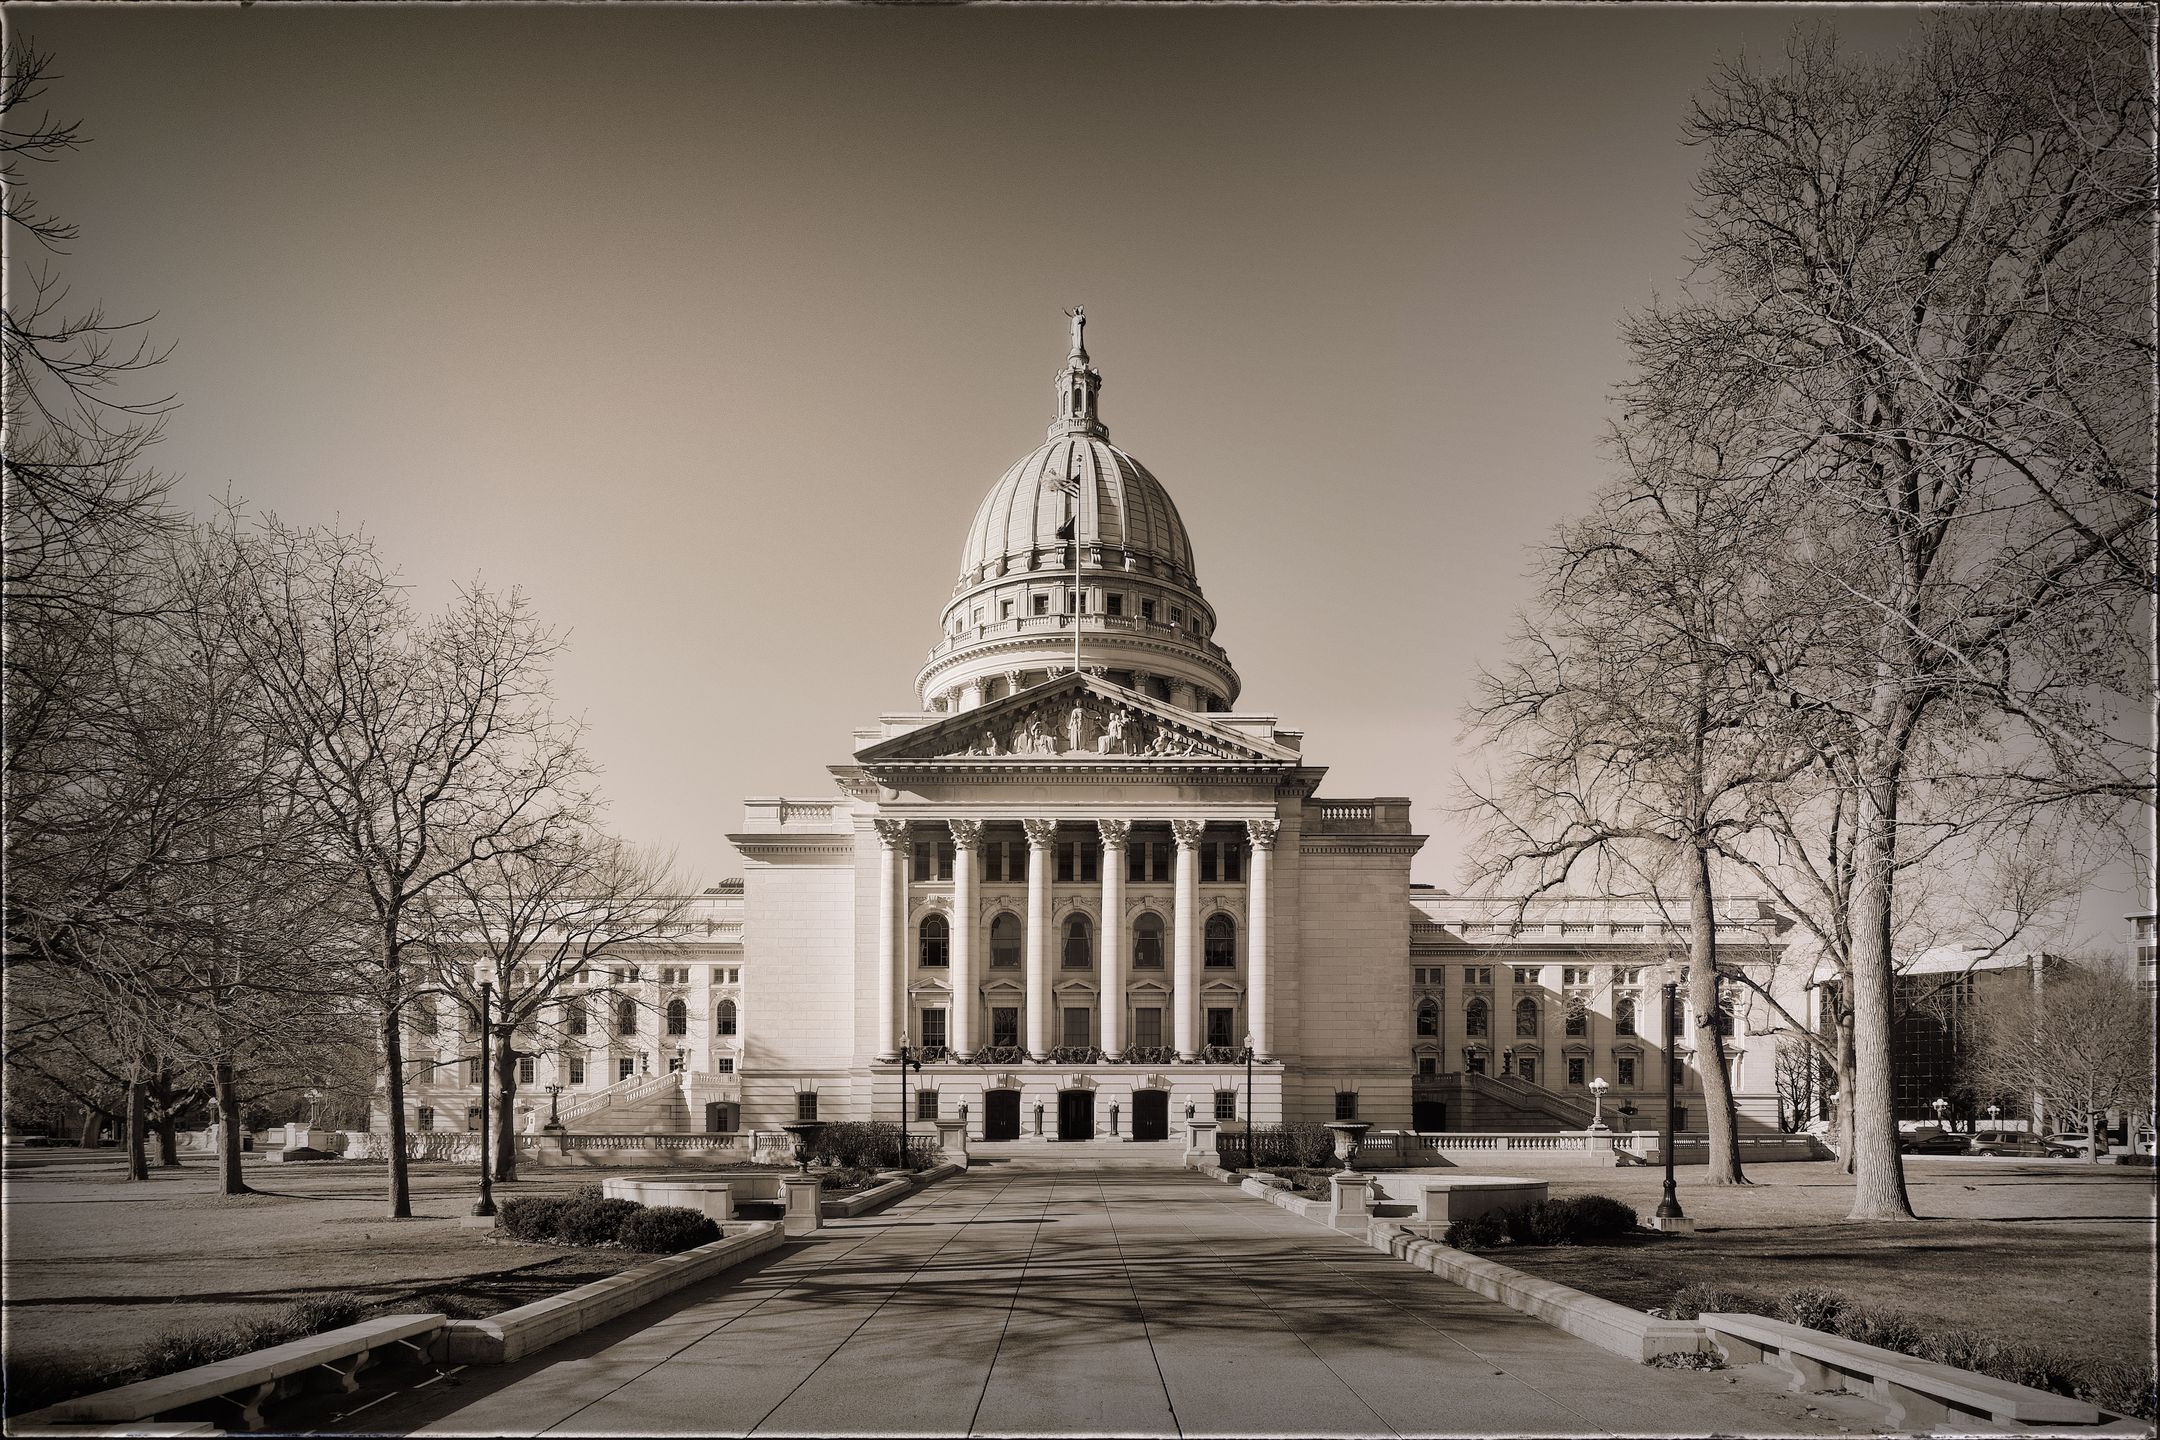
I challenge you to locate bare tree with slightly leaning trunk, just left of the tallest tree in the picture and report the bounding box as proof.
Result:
[1471,415,1808,1185]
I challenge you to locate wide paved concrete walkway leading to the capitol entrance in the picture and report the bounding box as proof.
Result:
[341,1151,1868,1436]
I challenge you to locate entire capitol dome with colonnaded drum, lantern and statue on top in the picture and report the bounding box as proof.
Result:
[916,317,1240,715]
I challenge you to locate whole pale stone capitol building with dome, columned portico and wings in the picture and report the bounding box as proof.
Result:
[397,313,1806,1142]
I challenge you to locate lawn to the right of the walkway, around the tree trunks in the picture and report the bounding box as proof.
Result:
[1495,1157,2154,1367]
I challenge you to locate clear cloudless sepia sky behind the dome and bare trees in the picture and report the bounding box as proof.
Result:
[4,4,2138,946]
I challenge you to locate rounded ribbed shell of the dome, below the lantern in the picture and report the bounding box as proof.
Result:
[959,436,1194,585]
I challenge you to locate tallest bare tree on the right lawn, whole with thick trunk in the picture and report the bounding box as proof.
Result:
[1637,9,2154,1220]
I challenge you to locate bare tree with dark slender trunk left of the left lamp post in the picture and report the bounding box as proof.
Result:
[235,518,590,1220]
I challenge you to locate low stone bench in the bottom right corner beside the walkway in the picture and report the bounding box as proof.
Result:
[1698,1315,2102,1429]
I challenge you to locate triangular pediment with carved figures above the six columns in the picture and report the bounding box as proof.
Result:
[855,674,1298,766]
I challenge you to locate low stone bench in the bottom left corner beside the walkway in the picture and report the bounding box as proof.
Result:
[27,1315,447,1434]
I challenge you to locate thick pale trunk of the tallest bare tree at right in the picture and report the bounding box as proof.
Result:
[1847,775,1914,1220]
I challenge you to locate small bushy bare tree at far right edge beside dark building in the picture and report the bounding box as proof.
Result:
[1968,956,2154,1161]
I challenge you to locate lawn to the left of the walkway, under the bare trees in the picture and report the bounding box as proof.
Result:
[0,1151,642,1367]
